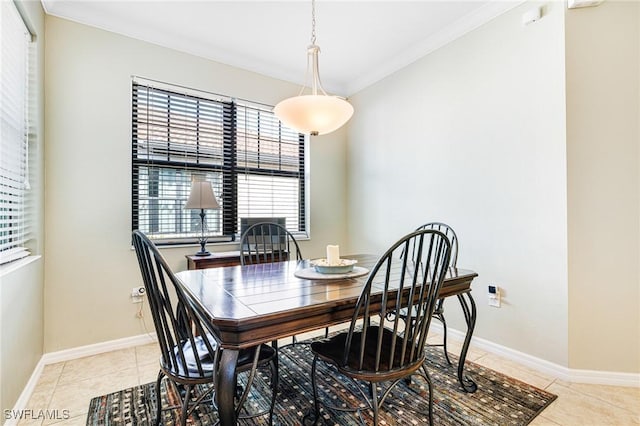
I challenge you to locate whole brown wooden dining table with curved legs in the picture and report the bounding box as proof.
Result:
[176,254,477,426]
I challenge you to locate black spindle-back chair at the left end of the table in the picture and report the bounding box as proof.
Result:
[132,231,278,425]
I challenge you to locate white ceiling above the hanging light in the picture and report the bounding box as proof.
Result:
[41,0,522,96]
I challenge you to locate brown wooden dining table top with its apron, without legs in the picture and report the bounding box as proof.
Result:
[176,255,477,349]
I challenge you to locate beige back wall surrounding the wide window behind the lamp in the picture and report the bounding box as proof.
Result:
[45,16,346,352]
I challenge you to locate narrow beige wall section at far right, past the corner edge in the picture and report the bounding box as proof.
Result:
[566,1,640,373]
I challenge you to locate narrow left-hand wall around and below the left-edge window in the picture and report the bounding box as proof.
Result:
[0,1,44,418]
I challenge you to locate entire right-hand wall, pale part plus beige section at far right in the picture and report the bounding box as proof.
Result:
[348,1,640,373]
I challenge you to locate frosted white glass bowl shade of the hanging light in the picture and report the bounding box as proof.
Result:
[273,95,353,136]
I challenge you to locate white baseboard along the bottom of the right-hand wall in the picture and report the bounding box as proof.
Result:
[431,321,640,387]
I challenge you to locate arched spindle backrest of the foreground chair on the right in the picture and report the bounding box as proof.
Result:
[343,229,451,372]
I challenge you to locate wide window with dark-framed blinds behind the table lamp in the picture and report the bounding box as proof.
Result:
[132,78,307,244]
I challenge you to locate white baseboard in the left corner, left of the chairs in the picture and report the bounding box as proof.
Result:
[9,333,156,426]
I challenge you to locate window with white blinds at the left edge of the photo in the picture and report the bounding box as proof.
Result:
[0,1,32,264]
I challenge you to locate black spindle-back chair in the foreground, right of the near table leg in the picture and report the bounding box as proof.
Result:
[311,229,451,425]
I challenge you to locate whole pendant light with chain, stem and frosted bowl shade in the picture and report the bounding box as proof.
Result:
[273,0,353,136]
